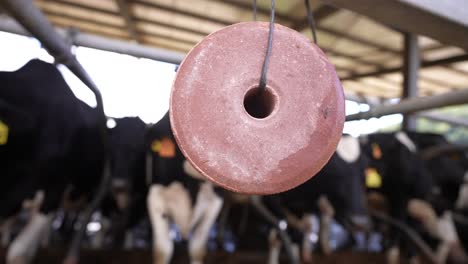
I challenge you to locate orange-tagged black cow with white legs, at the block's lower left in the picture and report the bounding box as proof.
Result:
[147,113,223,264]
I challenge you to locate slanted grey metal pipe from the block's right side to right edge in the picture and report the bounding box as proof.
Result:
[346,89,468,121]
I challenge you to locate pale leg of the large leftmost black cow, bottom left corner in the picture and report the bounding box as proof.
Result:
[6,213,51,264]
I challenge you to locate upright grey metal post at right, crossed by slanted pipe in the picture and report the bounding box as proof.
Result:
[402,33,421,131]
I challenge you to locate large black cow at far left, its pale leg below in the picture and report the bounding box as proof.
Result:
[0,60,105,262]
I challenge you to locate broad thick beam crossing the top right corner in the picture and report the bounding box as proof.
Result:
[324,0,468,50]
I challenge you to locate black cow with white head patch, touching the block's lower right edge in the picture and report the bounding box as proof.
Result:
[264,135,370,261]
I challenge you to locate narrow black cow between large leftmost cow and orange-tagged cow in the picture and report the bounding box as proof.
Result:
[98,117,148,247]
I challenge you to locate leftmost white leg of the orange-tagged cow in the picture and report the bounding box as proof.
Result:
[147,185,174,264]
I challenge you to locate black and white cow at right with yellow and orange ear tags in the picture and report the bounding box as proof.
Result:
[362,132,463,263]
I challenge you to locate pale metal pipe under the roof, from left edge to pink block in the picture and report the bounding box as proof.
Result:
[0,16,185,64]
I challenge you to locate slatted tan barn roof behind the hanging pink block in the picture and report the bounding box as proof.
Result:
[24,0,468,99]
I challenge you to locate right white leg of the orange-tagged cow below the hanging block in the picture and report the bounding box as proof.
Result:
[189,183,223,264]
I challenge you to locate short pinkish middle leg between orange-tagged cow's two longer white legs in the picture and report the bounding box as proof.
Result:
[164,182,192,239]
